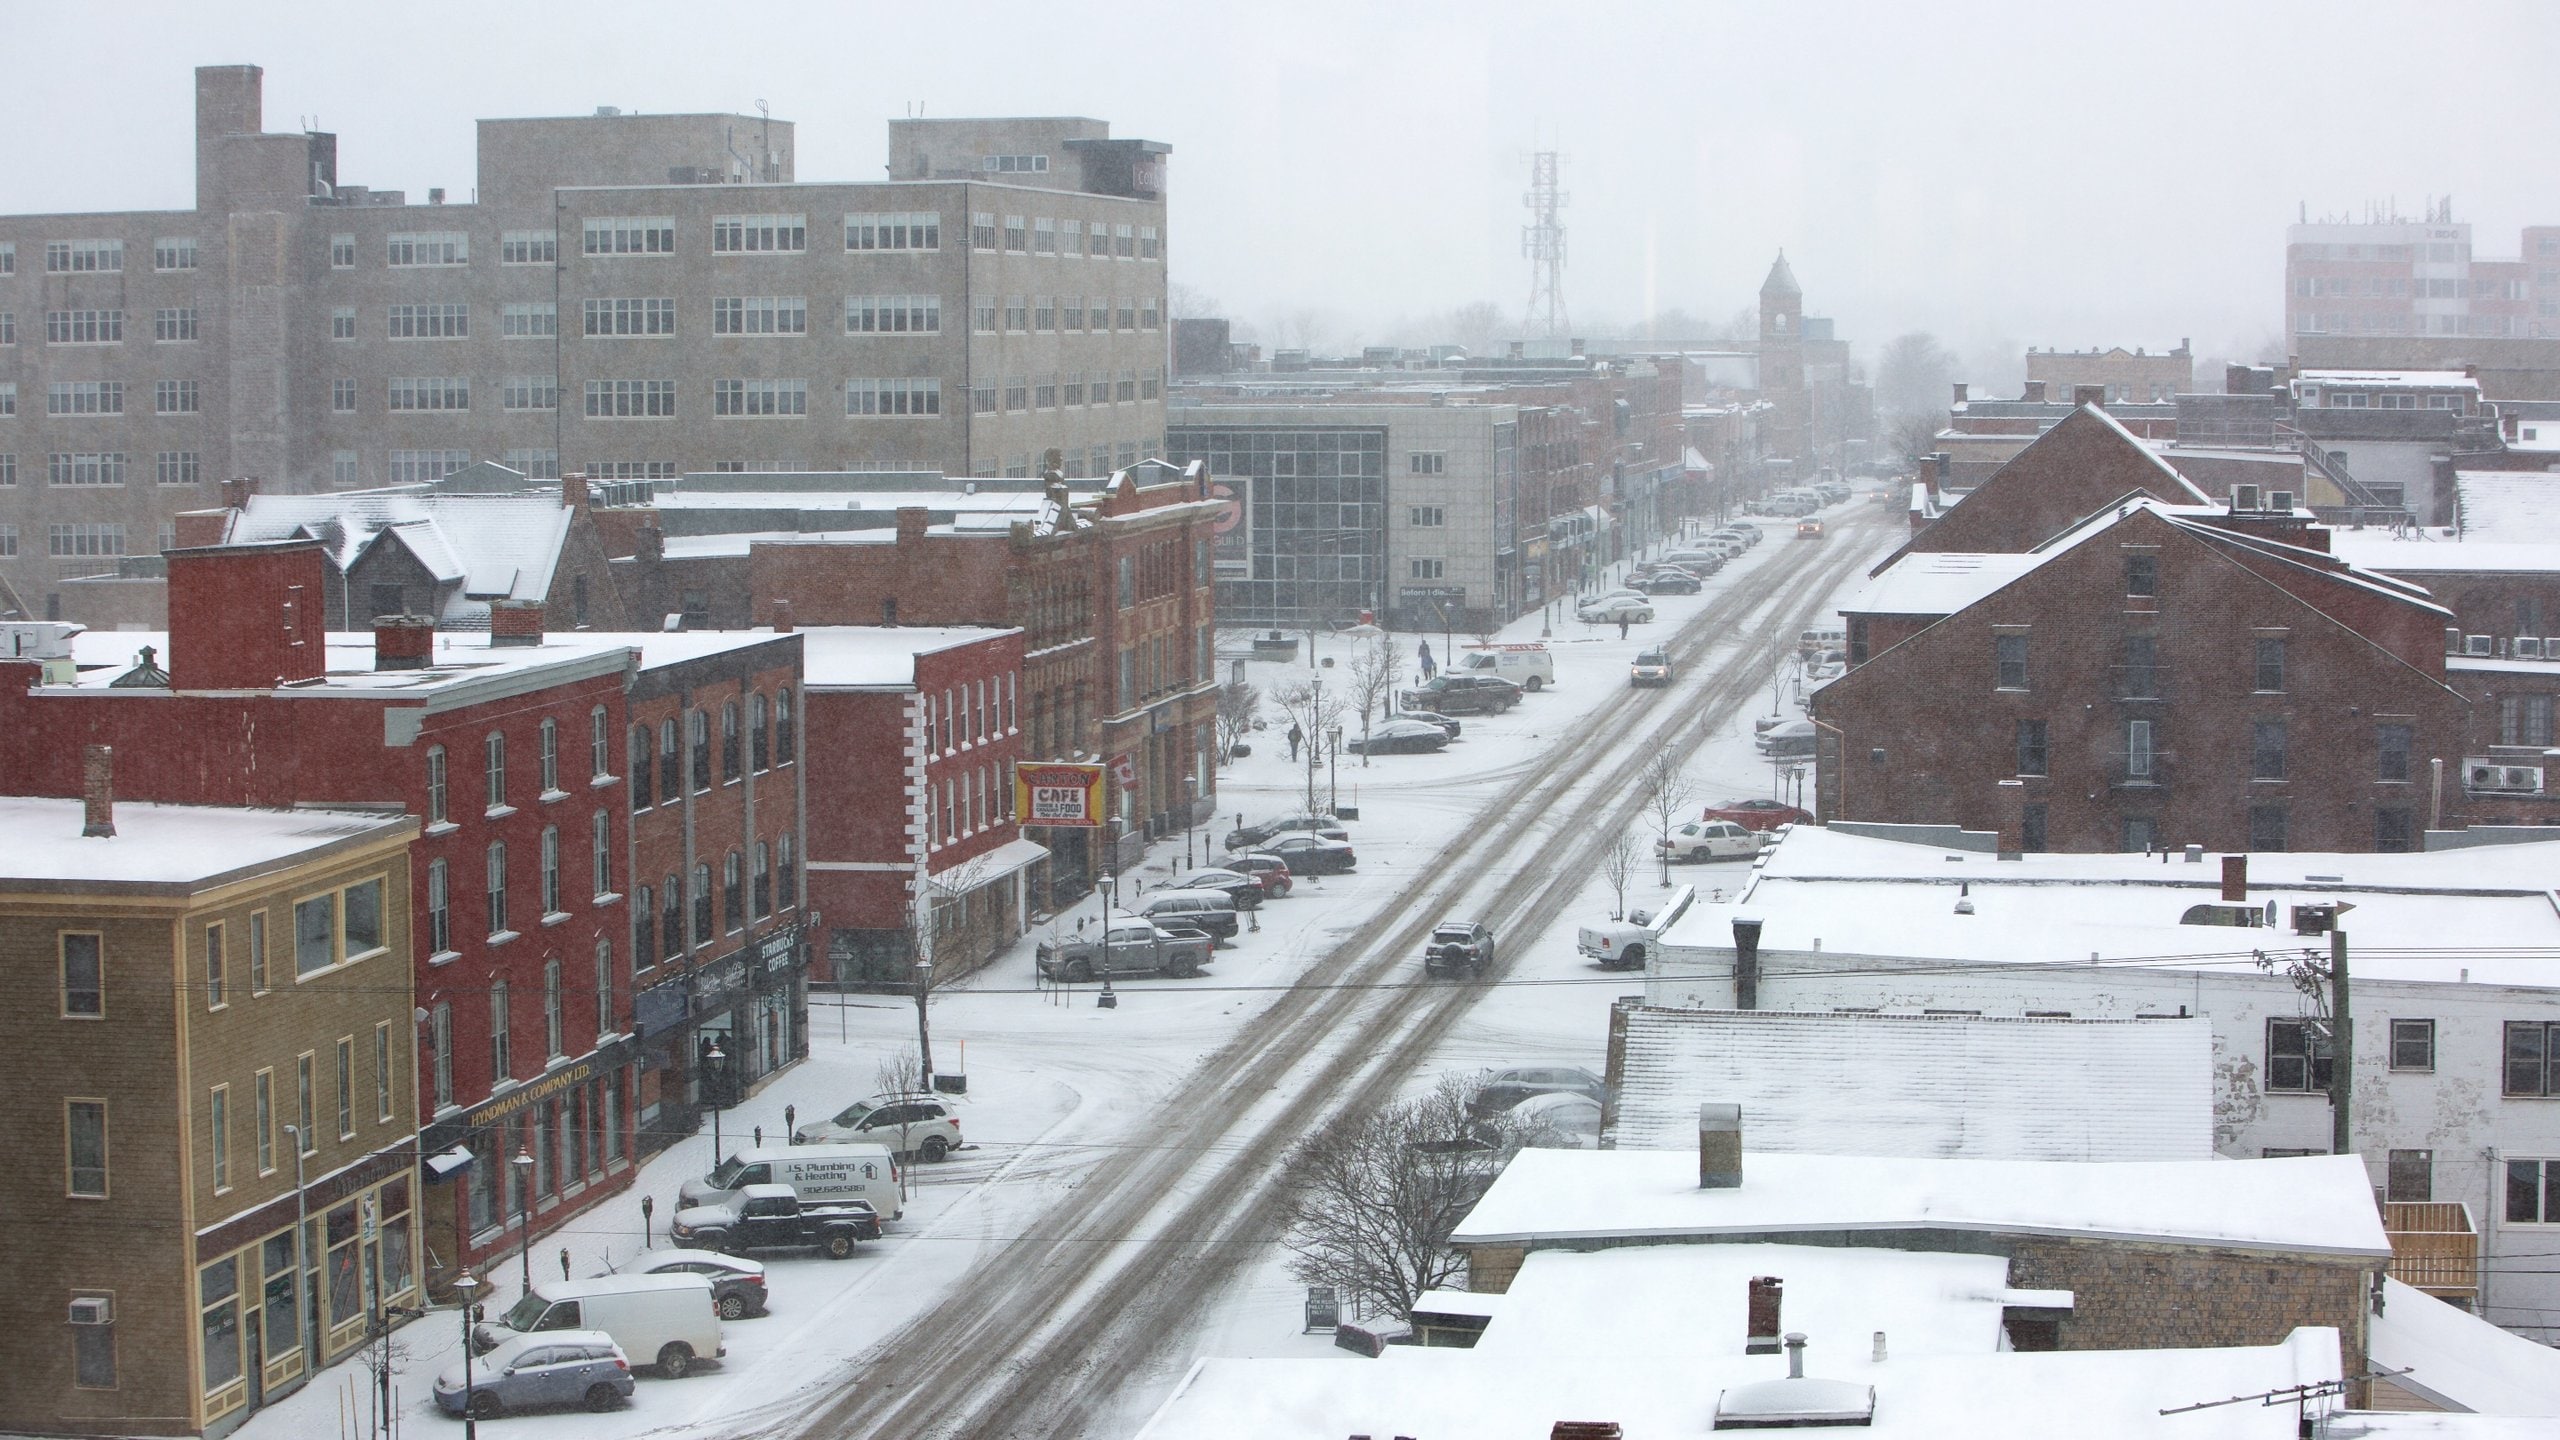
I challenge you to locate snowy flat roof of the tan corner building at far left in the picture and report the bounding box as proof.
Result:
[0,794,412,889]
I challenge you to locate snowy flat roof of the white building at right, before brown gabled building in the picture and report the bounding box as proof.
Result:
[1664,825,2560,986]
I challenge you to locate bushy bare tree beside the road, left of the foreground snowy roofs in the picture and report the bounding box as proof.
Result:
[1283,1076,1505,1320]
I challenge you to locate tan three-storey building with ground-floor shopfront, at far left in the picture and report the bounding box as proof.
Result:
[0,789,420,1435]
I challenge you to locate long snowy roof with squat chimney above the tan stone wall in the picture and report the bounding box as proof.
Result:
[1452,1137,2391,1256]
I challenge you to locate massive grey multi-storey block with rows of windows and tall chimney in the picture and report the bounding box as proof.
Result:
[0,67,1167,607]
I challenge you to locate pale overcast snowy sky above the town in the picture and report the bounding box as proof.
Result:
[20,0,2560,369]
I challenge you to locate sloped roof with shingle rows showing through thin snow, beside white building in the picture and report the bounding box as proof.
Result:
[1608,1007,2214,1161]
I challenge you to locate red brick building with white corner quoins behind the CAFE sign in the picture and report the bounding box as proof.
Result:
[801,625,1047,989]
